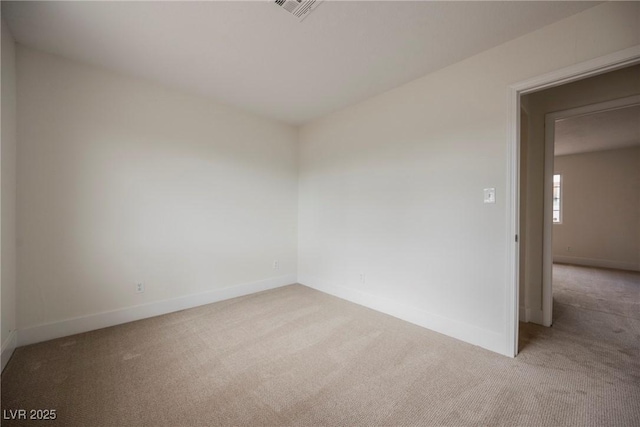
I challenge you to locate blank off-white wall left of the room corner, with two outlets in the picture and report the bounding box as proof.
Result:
[17,46,297,343]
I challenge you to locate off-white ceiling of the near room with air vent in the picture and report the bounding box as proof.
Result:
[2,0,599,124]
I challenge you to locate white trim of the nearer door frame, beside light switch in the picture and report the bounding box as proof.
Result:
[505,45,640,357]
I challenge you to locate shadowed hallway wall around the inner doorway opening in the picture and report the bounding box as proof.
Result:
[521,65,640,323]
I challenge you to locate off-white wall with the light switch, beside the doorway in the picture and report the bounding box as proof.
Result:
[298,2,640,354]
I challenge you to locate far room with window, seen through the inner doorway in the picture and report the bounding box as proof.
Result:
[552,103,640,324]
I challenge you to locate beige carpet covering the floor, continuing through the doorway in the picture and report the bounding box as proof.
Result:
[2,266,640,426]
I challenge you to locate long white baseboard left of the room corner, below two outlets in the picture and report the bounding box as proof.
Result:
[18,274,296,348]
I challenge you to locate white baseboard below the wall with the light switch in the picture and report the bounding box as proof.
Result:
[298,275,513,357]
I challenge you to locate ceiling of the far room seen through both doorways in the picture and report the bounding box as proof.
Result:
[554,105,640,156]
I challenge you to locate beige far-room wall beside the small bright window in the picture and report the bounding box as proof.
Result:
[553,147,640,271]
